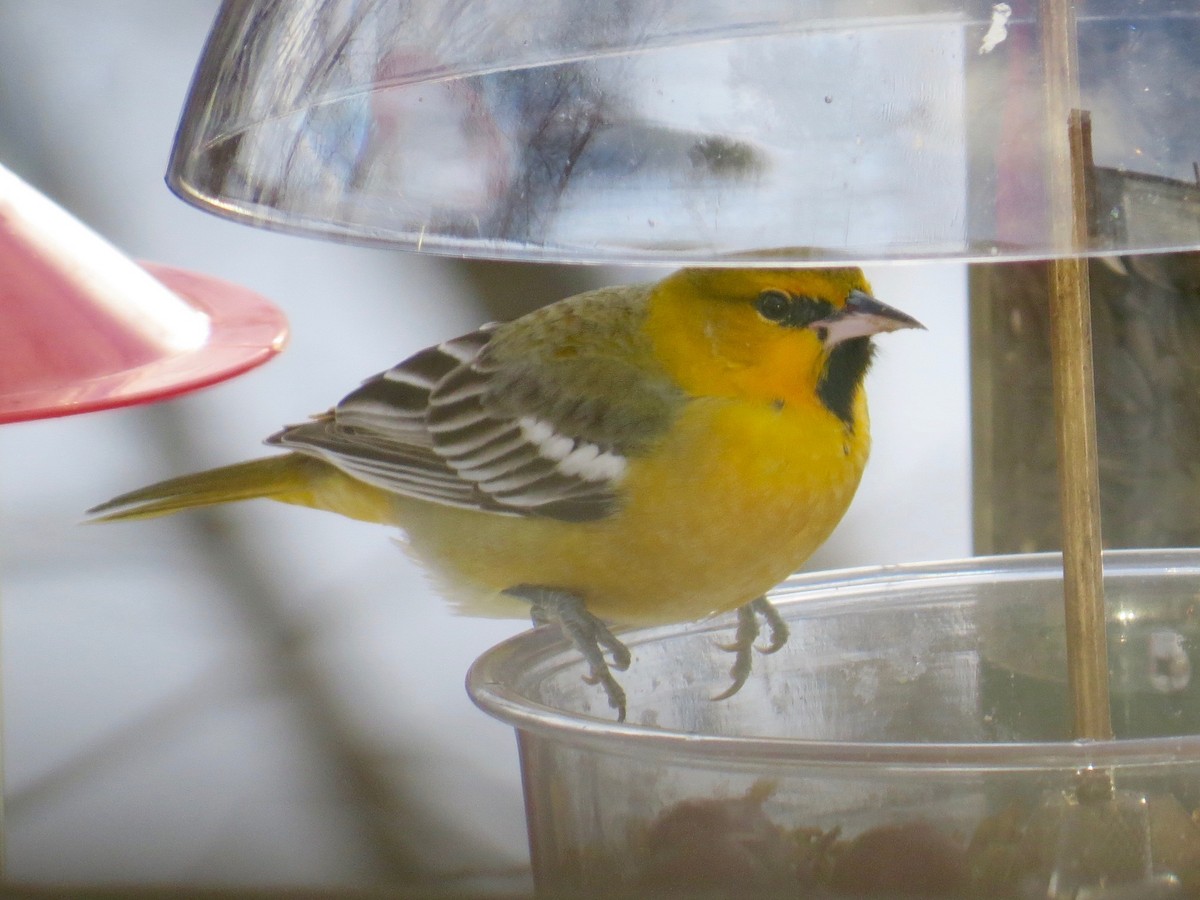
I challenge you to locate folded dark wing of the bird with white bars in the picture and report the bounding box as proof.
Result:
[268,304,678,521]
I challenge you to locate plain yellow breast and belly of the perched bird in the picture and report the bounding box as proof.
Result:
[398,391,869,624]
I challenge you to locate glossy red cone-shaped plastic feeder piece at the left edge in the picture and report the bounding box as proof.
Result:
[0,167,287,422]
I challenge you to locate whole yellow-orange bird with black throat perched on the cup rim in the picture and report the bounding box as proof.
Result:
[90,268,920,718]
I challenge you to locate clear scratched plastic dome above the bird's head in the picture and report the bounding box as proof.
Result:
[169,0,1200,263]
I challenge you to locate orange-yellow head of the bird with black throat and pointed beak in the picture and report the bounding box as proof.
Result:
[648,268,923,425]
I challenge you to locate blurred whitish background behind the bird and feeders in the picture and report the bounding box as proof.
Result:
[0,0,970,887]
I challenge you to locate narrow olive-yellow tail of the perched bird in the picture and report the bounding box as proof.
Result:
[88,454,326,522]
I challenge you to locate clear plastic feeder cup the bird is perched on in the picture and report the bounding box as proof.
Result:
[468,550,1200,898]
